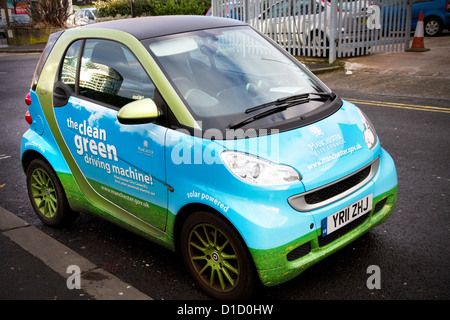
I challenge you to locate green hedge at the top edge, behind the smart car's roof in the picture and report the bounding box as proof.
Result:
[94,0,211,17]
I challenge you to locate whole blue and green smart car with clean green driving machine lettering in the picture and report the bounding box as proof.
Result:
[21,16,397,299]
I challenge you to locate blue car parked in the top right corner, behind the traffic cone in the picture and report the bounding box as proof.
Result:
[411,0,450,37]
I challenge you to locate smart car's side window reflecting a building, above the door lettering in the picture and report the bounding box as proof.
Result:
[60,39,155,108]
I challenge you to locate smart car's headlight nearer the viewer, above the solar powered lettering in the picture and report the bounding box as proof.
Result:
[220,151,301,185]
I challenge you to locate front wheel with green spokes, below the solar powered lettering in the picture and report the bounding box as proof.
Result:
[181,212,255,300]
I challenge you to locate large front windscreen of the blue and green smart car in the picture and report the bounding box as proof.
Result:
[143,26,332,130]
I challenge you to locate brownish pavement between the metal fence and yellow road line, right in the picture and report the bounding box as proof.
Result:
[306,31,450,100]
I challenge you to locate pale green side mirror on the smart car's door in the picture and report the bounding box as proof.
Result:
[117,98,160,124]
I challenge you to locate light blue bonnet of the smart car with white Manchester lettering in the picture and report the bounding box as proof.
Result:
[216,101,380,191]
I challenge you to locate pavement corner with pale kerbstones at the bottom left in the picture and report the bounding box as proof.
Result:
[0,207,152,300]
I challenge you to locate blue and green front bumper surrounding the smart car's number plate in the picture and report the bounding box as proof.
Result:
[249,151,397,286]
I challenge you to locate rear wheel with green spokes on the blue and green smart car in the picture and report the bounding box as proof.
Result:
[27,159,76,227]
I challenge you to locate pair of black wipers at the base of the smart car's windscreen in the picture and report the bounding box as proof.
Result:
[227,92,336,129]
